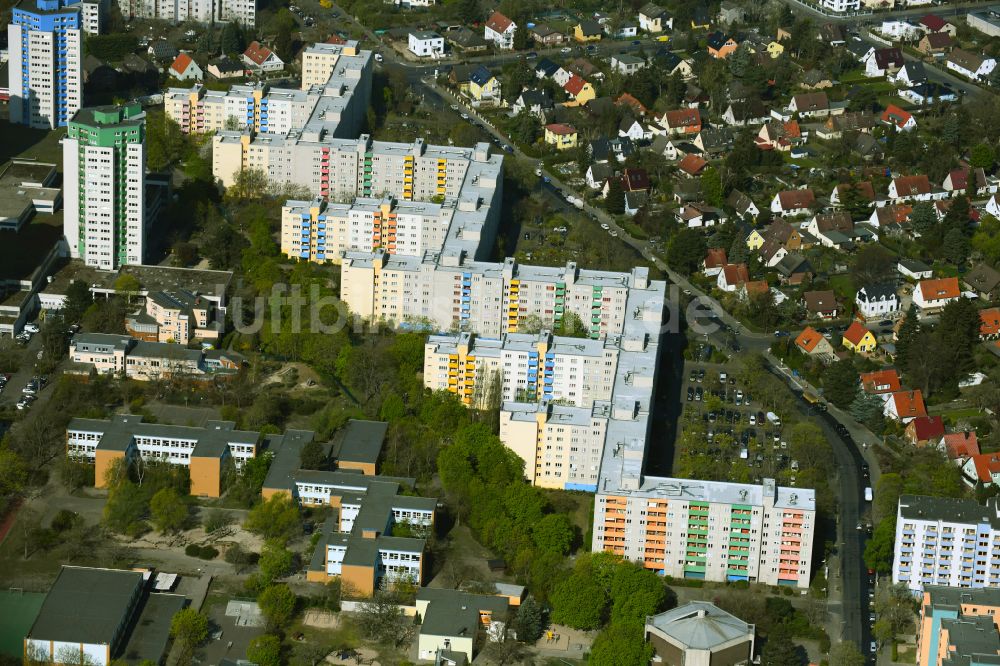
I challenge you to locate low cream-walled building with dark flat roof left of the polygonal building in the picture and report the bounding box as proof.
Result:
[417,588,508,662]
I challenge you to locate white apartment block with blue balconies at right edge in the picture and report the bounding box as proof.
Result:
[892,495,1000,592]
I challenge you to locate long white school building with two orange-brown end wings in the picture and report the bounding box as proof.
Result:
[66,414,262,497]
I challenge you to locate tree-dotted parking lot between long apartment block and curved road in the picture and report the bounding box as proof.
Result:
[677,361,798,486]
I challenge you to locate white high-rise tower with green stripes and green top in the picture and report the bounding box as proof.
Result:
[62,104,147,271]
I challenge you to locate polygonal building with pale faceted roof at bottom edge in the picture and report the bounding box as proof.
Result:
[646,601,754,666]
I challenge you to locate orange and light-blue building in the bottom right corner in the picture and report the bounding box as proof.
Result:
[917,585,1000,666]
